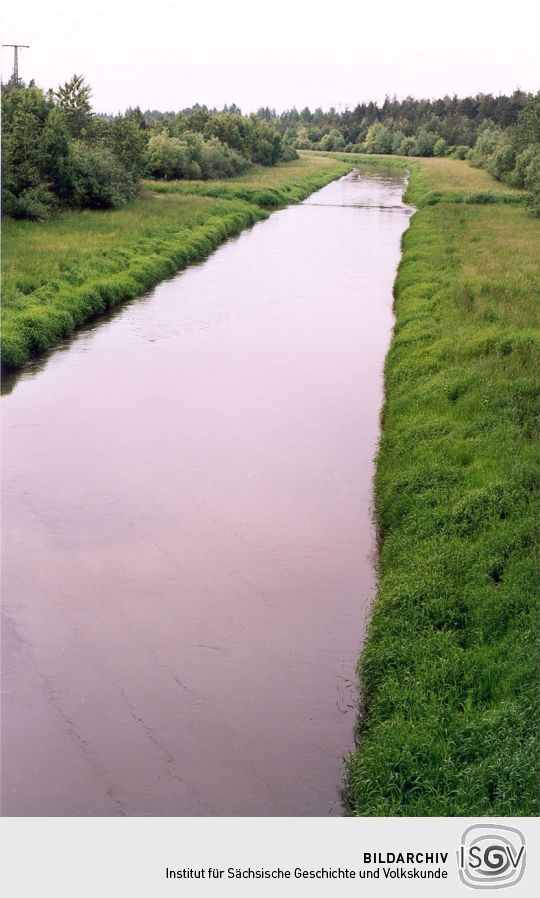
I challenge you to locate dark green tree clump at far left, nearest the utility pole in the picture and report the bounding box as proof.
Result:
[2,82,145,220]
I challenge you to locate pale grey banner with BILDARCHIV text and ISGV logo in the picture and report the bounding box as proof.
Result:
[0,817,540,898]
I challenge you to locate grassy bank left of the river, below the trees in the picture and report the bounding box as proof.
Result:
[2,157,352,369]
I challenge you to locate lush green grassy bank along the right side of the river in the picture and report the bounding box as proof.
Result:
[346,160,540,816]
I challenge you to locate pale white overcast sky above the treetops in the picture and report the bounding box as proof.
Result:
[2,0,540,112]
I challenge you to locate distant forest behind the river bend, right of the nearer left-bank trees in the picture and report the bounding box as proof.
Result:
[259,91,540,215]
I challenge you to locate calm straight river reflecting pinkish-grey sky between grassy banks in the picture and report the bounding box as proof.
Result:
[1,168,408,816]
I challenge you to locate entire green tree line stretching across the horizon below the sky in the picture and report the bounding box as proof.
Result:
[2,75,540,219]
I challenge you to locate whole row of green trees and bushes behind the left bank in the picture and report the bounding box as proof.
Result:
[2,75,296,219]
